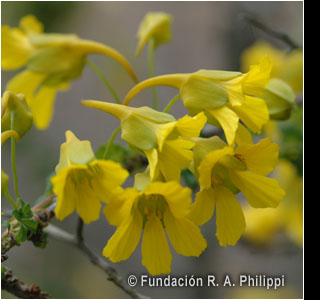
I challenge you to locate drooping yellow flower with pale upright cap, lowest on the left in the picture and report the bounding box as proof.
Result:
[51,131,128,223]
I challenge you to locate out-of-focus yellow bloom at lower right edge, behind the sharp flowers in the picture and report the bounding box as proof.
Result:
[244,160,303,247]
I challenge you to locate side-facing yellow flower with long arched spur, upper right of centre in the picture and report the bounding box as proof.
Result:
[124,57,272,144]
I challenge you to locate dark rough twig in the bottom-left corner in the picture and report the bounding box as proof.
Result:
[1,269,51,299]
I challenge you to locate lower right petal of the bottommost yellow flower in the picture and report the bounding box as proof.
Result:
[164,210,207,256]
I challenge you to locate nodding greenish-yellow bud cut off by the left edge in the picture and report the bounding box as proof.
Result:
[1,91,33,137]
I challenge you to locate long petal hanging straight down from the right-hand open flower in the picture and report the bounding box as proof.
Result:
[214,185,246,247]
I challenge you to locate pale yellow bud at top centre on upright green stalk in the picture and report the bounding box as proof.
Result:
[136,12,172,56]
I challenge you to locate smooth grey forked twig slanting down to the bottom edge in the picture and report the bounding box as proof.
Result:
[46,218,147,299]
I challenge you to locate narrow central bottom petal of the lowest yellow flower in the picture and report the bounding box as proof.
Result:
[141,215,172,276]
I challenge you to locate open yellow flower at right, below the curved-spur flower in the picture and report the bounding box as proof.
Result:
[190,137,285,246]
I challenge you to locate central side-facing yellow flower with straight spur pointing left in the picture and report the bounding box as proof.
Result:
[82,100,207,181]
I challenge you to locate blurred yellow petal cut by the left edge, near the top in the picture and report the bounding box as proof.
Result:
[1,25,33,70]
